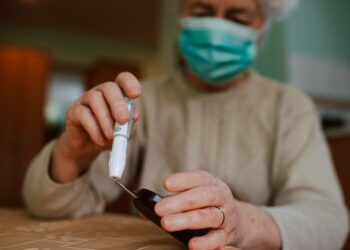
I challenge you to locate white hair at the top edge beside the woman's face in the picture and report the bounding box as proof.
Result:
[168,0,299,22]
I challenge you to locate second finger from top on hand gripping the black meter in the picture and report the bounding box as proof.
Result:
[155,186,225,216]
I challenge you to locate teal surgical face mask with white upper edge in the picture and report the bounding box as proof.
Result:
[178,17,259,85]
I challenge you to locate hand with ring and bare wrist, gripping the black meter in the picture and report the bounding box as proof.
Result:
[155,171,281,250]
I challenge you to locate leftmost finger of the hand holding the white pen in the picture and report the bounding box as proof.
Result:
[75,105,106,147]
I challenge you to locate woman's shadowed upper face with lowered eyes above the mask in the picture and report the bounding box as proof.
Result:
[180,0,265,30]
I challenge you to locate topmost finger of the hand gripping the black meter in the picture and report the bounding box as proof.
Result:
[163,170,218,193]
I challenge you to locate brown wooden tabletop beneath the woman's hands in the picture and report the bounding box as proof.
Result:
[0,209,235,250]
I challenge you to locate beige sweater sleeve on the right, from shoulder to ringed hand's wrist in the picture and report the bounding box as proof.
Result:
[266,87,349,250]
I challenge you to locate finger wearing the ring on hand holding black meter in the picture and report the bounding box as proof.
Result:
[161,207,223,232]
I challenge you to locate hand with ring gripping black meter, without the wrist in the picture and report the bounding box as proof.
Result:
[155,171,244,249]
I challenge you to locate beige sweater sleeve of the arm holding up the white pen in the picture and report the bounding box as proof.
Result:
[22,99,144,218]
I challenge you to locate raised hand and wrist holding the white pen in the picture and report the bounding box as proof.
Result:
[50,73,141,183]
